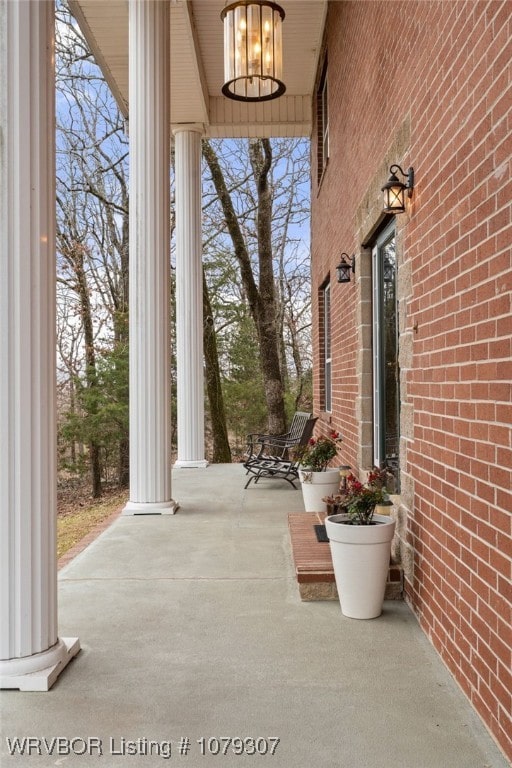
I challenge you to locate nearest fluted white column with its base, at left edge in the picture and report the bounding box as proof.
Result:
[0,0,80,691]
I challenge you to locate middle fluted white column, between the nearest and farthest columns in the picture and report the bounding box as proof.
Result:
[124,0,177,515]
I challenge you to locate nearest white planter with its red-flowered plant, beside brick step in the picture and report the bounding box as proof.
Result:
[325,474,395,619]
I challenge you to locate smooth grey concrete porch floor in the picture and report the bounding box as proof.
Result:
[0,465,508,768]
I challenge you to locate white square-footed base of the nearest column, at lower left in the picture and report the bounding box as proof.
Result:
[0,637,80,691]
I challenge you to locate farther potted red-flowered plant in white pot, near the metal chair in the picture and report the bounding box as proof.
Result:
[295,431,342,512]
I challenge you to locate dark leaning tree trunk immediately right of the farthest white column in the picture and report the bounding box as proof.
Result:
[203,270,231,464]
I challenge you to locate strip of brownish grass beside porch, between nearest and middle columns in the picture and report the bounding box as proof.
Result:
[57,491,127,557]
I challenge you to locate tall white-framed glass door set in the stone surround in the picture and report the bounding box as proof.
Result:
[372,225,400,492]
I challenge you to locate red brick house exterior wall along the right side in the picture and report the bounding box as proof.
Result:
[312,0,512,759]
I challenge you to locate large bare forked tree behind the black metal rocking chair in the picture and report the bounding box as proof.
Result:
[203,139,309,432]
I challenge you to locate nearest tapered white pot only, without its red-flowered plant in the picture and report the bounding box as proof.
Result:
[325,514,395,619]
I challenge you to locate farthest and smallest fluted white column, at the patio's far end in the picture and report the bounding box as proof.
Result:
[173,124,208,467]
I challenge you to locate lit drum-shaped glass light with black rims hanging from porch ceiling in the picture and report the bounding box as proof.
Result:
[220,0,286,101]
